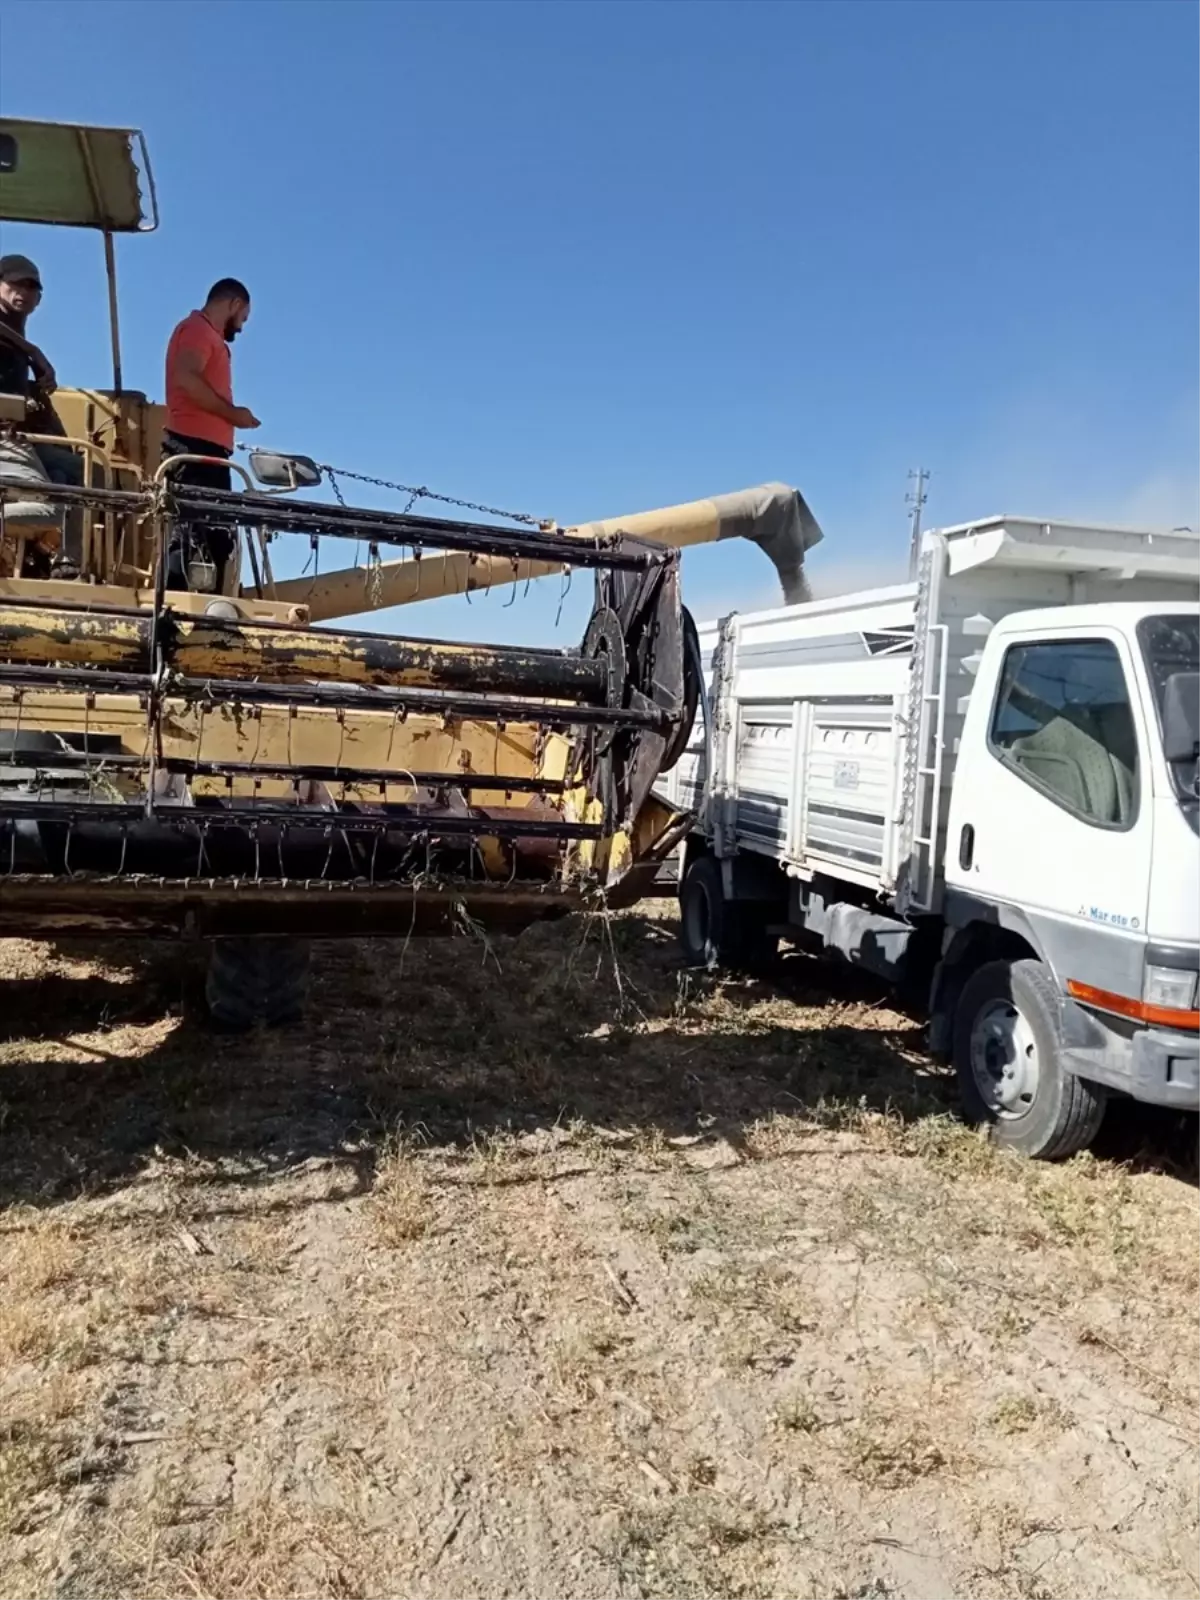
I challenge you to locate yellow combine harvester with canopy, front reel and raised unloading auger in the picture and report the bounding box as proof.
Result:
[0,120,819,1027]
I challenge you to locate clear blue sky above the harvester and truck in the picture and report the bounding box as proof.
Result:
[0,0,1200,642]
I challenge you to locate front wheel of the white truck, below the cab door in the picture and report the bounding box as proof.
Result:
[954,960,1106,1162]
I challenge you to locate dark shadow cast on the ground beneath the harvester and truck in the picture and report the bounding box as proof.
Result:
[0,917,1200,1205]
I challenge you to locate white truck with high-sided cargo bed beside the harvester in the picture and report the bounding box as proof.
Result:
[666,517,1200,1158]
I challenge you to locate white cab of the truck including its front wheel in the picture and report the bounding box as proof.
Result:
[933,600,1200,1154]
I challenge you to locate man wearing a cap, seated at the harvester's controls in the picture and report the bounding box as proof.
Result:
[0,254,83,578]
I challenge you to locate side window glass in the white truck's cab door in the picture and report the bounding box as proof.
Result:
[990,638,1138,827]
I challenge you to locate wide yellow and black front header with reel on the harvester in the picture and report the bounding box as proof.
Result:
[0,467,694,940]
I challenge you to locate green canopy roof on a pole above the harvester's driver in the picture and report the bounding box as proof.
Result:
[0,117,158,234]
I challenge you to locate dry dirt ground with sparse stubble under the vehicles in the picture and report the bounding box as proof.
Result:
[0,915,1200,1600]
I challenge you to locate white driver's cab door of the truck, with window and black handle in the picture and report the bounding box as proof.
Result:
[946,626,1152,995]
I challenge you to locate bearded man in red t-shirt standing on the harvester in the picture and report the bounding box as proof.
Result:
[163,278,259,594]
